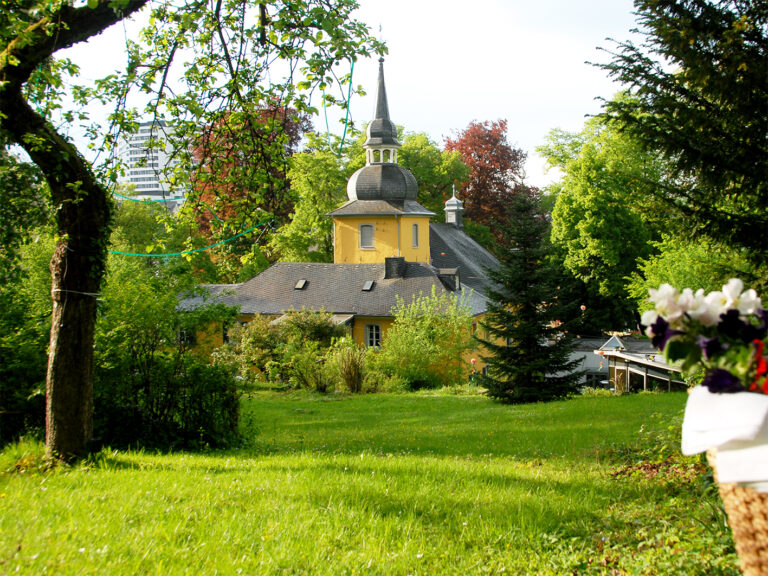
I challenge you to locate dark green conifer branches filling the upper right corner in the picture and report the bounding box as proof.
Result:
[600,0,768,262]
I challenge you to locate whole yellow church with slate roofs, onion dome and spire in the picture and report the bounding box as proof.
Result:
[190,60,498,356]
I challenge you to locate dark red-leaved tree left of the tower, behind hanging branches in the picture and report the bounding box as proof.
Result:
[187,105,312,282]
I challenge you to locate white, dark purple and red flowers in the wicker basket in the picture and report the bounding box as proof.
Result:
[641,278,768,394]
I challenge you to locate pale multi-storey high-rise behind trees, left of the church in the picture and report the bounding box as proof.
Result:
[118,121,184,209]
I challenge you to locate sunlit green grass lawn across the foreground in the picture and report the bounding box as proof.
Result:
[0,393,739,575]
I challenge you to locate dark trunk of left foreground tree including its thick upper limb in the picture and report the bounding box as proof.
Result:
[0,0,147,459]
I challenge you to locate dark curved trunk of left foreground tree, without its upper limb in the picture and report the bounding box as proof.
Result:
[0,94,112,460]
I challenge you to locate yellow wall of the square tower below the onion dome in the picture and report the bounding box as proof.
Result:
[333,216,429,264]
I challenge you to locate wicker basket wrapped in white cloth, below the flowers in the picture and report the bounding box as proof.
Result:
[682,386,768,576]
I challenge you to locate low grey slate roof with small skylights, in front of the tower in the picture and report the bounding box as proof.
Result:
[181,262,487,317]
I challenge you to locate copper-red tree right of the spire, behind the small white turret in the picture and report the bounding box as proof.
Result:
[445,120,526,235]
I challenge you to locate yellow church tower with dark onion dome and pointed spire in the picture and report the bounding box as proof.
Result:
[329,58,435,264]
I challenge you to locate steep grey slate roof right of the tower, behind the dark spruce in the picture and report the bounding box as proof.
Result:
[429,222,499,295]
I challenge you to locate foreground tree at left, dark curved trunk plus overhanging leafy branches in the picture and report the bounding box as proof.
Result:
[0,0,383,458]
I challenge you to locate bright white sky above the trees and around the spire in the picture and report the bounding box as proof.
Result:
[64,0,635,186]
